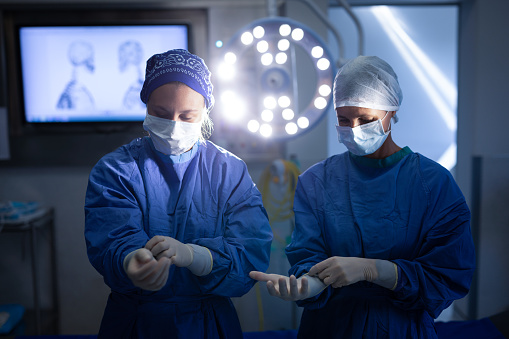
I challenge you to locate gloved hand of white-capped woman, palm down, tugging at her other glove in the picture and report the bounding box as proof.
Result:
[308,257,377,288]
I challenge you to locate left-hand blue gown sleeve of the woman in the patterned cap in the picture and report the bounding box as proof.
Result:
[85,152,149,292]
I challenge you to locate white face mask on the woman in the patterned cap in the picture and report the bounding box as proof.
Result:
[143,114,202,155]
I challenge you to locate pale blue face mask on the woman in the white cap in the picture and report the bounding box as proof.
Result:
[336,112,391,156]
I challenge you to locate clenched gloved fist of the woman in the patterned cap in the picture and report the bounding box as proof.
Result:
[124,248,171,291]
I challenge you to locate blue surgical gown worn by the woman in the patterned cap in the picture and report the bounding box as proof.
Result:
[85,137,272,339]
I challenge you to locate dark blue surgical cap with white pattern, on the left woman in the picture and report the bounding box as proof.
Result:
[140,49,214,112]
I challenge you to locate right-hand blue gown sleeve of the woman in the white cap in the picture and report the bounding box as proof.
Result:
[393,165,475,318]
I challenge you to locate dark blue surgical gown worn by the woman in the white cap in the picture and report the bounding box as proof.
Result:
[286,147,475,339]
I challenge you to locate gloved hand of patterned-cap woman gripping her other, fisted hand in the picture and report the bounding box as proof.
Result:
[145,235,193,267]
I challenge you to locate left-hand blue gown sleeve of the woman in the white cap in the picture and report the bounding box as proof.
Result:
[285,171,332,309]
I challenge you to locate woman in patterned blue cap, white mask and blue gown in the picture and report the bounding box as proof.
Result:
[85,49,272,339]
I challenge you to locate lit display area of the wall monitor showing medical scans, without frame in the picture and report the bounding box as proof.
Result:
[19,24,189,123]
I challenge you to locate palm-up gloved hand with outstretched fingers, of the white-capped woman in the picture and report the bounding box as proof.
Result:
[249,271,327,301]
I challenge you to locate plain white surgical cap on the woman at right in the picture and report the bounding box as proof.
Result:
[334,56,403,111]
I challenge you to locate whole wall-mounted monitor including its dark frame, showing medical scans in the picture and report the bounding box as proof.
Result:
[0,4,207,137]
